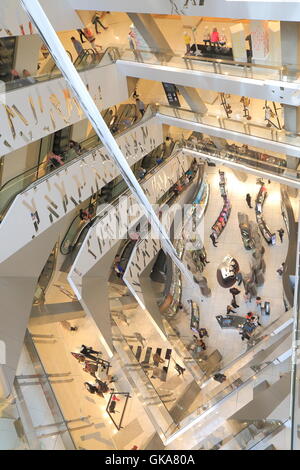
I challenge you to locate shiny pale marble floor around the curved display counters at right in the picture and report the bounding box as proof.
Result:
[174,167,296,366]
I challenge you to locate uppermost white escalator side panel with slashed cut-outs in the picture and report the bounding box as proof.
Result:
[0,64,128,159]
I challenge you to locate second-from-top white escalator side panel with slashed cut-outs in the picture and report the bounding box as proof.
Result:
[0,117,163,263]
